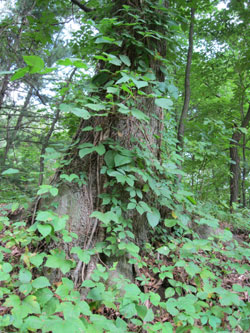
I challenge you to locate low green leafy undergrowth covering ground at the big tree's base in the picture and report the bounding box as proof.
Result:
[0,204,250,333]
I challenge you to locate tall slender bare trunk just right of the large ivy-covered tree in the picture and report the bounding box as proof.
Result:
[177,8,195,152]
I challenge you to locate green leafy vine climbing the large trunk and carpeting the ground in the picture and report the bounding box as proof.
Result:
[0,1,250,333]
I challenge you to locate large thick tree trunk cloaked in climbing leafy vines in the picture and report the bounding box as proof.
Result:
[32,0,180,282]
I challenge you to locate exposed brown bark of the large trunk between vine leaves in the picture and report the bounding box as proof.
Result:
[38,1,166,284]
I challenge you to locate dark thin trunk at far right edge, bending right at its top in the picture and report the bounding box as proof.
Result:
[229,104,250,208]
